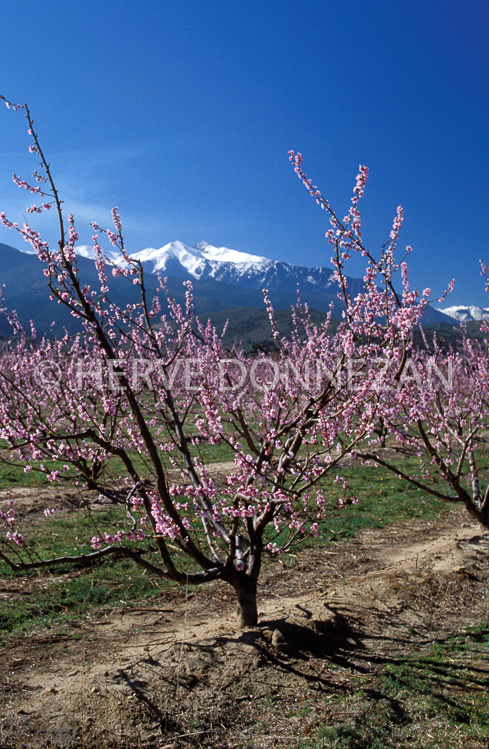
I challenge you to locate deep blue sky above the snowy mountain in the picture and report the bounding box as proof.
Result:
[0,0,489,306]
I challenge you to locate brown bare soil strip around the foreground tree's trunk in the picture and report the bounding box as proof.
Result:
[0,502,489,749]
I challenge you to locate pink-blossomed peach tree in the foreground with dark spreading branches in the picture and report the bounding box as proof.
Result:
[0,99,456,626]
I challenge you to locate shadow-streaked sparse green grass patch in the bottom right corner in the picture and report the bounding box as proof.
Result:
[292,624,489,749]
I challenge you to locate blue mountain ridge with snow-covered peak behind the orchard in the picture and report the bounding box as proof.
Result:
[0,241,454,335]
